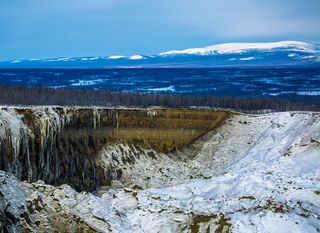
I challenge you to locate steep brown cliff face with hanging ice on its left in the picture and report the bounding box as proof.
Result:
[0,107,229,190]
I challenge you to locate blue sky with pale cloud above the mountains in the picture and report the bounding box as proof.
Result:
[0,0,320,60]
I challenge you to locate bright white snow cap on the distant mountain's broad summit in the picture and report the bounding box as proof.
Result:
[158,41,317,56]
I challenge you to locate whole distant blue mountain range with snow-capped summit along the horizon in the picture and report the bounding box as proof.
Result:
[0,41,320,68]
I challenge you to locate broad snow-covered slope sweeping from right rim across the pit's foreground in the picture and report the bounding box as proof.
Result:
[6,112,320,233]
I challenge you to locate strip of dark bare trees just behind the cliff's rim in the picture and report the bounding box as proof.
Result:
[0,85,320,112]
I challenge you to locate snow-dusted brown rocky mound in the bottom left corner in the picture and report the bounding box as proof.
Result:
[0,171,98,233]
